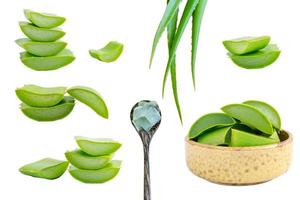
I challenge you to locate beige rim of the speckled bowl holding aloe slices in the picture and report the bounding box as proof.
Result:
[185,130,293,151]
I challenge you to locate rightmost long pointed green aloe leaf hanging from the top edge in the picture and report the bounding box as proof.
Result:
[191,0,207,89]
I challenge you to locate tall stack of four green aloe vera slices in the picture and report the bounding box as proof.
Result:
[16,10,75,71]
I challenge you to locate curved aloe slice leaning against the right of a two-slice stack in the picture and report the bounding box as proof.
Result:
[67,86,109,119]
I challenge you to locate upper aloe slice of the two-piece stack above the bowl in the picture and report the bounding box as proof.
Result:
[223,36,271,55]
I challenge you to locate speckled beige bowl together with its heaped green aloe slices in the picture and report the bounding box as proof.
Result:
[186,100,293,185]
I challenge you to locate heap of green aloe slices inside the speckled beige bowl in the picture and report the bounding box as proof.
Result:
[189,100,281,147]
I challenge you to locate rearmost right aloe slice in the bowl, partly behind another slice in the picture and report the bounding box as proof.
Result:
[244,100,281,130]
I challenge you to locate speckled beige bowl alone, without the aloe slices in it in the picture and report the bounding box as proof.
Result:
[186,131,293,185]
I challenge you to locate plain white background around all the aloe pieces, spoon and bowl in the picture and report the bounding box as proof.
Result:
[0,0,300,200]
